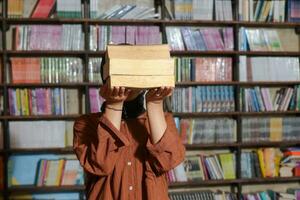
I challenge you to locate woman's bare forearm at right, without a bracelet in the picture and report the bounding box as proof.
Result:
[147,101,167,144]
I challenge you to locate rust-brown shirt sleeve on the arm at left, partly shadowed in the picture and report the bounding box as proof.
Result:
[73,115,129,176]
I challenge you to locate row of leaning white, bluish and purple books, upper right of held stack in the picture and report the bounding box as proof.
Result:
[166,26,234,51]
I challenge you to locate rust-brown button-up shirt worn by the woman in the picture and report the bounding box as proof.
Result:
[74,113,185,200]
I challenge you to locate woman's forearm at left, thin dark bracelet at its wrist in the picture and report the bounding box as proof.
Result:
[104,102,123,130]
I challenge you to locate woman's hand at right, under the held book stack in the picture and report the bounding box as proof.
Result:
[146,87,174,103]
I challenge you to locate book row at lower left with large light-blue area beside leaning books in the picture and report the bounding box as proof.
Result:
[8,154,83,187]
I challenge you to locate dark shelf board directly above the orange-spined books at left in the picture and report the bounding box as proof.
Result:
[5,50,86,57]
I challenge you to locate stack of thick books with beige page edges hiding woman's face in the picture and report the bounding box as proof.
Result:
[103,45,175,88]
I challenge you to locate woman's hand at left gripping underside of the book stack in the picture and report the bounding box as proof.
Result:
[100,82,131,104]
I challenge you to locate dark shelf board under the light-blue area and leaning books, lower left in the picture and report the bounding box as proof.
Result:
[8,185,84,194]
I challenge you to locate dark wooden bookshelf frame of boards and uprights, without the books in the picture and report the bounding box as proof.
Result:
[0,0,300,199]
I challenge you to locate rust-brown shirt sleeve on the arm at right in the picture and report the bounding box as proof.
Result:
[146,113,185,175]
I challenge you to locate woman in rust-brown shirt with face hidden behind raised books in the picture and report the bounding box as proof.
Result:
[74,74,185,200]
